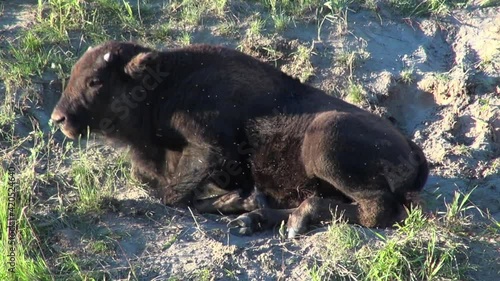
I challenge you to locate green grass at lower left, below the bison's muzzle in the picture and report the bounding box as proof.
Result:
[0,123,130,280]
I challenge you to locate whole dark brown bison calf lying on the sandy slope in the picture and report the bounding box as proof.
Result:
[52,42,428,235]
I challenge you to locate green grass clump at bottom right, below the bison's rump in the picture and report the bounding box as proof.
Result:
[309,201,468,281]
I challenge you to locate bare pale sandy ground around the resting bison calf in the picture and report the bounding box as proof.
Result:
[0,1,500,280]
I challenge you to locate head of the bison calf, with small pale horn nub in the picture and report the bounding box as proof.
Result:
[51,41,161,139]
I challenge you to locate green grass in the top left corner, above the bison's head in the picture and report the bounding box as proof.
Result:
[0,0,156,89]
